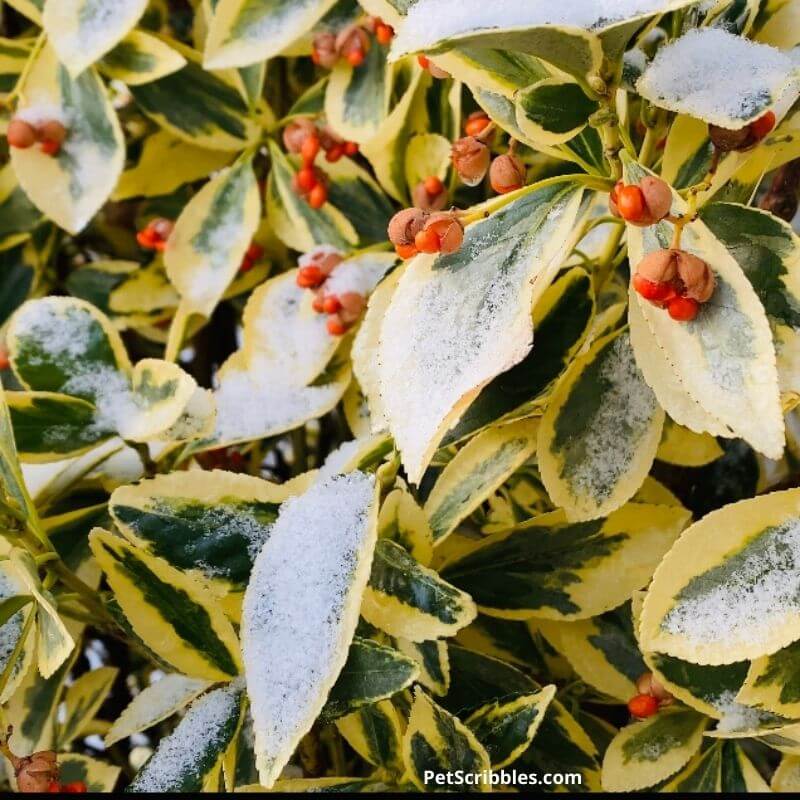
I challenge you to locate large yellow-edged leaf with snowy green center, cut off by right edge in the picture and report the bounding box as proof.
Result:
[640,490,800,664]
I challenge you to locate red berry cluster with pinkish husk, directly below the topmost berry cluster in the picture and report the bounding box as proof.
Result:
[283,117,358,208]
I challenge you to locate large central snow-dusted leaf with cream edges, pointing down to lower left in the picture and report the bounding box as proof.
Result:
[377,192,575,482]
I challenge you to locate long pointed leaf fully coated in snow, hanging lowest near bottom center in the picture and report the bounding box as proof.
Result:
[241,472,375,788]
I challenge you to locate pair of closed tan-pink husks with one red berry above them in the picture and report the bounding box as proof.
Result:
[451,111,526,194]
